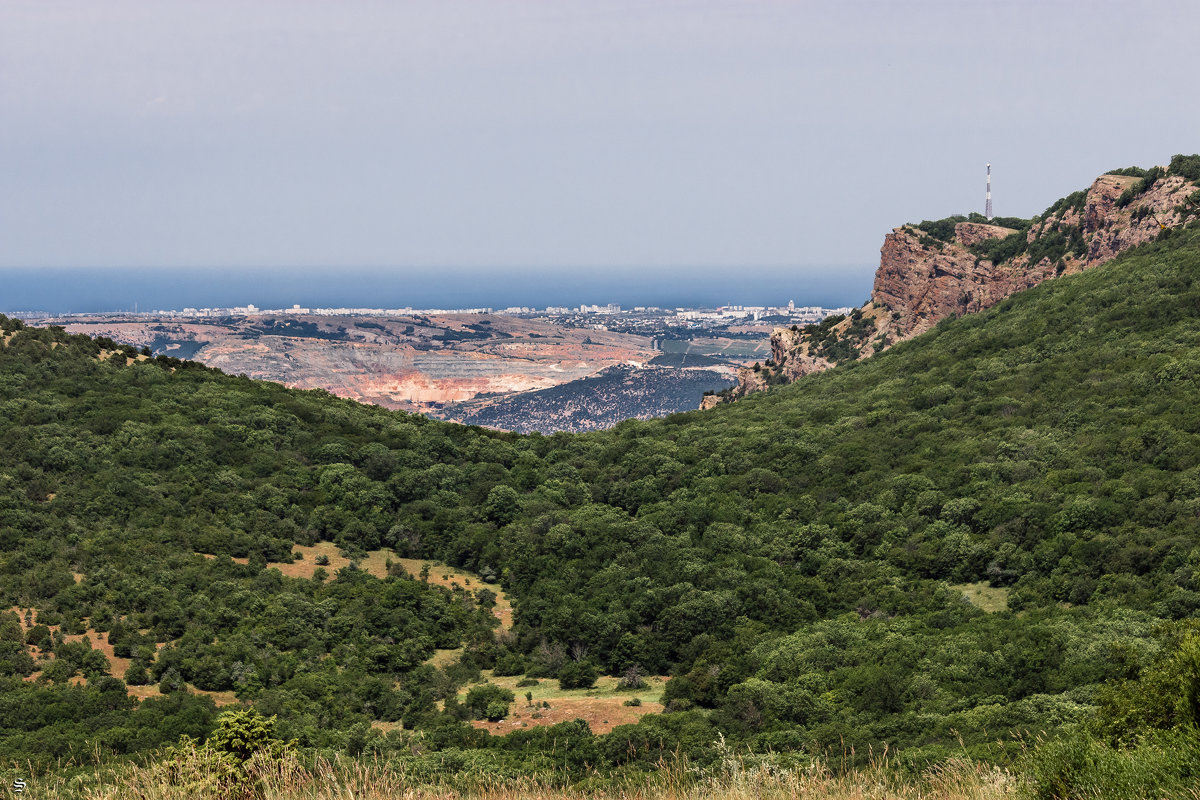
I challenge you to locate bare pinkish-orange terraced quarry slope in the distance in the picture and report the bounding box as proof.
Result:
[29,314,655,411]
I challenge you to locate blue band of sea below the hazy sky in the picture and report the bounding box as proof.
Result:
[0,265,875,314]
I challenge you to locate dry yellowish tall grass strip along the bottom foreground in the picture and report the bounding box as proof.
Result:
[14,750,1018,800]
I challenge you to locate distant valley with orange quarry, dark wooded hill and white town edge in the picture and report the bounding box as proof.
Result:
[18,308,792,434]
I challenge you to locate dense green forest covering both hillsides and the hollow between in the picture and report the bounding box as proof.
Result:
[7,221,1200,796]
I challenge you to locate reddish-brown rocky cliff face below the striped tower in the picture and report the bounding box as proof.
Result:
[706,163,1200,408]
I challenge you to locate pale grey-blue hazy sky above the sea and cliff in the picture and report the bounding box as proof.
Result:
[0,0,1200,281]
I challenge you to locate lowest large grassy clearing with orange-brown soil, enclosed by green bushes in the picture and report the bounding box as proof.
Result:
[460,670,667,735]
